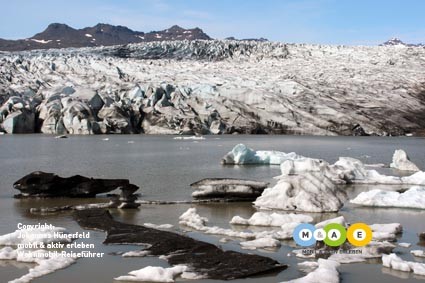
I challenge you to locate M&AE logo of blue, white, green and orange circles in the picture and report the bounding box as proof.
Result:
[292,223,372,247]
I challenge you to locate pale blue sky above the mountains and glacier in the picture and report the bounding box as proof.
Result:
[0,0,425,45]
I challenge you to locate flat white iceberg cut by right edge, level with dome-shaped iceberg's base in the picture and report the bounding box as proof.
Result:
[350,189,425,209]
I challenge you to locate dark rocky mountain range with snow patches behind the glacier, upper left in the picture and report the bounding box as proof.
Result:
[0,23,211,51]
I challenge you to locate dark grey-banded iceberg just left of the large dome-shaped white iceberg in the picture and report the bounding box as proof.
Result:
[190,178,269,201]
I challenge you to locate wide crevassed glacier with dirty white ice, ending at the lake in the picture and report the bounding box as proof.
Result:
[0,40,425,135]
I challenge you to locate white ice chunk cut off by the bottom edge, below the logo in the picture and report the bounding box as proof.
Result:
[282,258,340,283]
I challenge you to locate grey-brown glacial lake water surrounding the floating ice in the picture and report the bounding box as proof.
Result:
[0,135,425,283]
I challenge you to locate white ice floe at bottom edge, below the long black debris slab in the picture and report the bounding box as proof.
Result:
[114,265,188,282]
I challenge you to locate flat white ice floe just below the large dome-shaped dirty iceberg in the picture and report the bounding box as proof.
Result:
[230,212,313,229]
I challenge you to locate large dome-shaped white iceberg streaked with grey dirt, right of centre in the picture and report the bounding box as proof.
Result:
[254,172,346,212]
